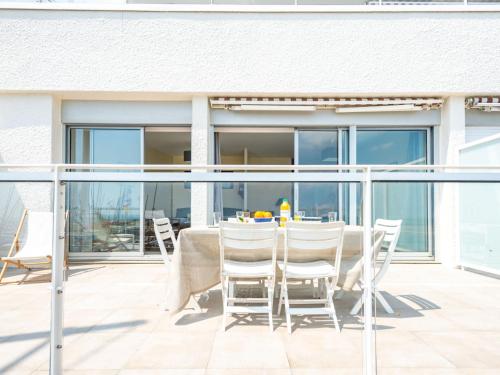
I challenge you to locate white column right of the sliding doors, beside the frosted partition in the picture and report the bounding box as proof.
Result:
[435,96,465,267]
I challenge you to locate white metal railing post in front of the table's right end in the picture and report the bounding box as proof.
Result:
[363,167,377,375]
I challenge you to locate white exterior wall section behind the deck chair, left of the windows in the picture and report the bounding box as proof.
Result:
[0,95,58,254]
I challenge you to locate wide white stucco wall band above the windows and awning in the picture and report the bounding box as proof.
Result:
[0,9,500,95]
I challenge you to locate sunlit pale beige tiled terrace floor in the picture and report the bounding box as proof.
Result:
[0,264,500,375]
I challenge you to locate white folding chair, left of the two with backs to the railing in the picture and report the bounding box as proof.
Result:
[219,221,278,332]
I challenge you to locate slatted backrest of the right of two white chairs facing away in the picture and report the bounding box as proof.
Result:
[284,221,345,272]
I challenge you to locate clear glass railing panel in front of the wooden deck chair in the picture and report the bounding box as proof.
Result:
[0,181,52,374]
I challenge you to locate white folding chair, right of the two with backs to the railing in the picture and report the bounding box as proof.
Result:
[278,221,345,333]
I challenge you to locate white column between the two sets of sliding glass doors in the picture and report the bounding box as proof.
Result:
[191,96,213,227]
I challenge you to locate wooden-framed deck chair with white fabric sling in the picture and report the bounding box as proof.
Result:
[0,210,53,282]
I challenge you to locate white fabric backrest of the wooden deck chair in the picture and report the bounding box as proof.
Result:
[20,211,54,256]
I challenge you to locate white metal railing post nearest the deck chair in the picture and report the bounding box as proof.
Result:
[50,166,66,375]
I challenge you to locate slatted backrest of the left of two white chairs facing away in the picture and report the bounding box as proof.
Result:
[219,221,278,272]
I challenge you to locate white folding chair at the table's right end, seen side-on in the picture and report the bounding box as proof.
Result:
[351,219,403,315]
